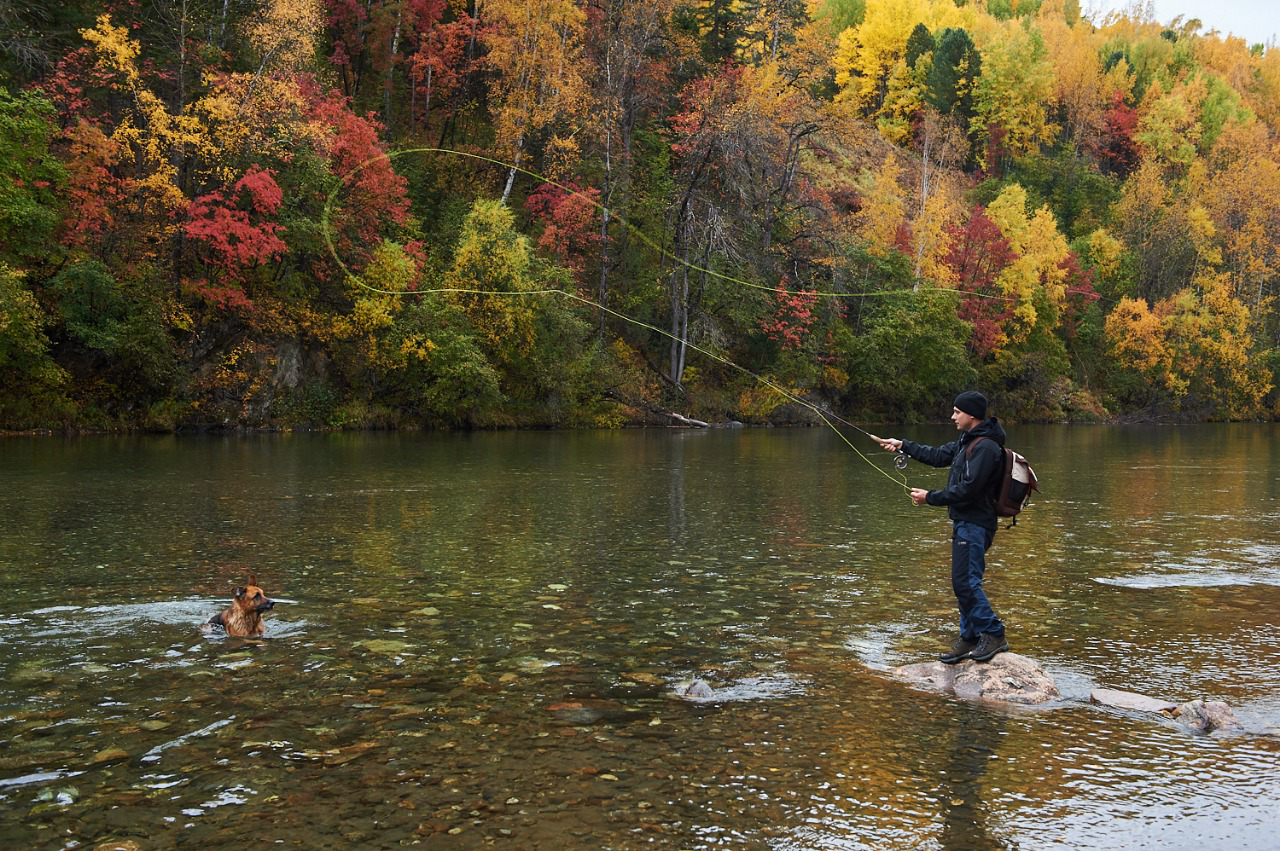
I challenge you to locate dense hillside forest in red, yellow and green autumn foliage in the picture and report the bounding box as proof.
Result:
[0,0,1280,429]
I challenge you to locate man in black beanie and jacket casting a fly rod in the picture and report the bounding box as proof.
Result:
[879,390,1009,664]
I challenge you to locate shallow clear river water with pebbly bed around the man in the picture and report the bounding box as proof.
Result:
[0,426,1280,850]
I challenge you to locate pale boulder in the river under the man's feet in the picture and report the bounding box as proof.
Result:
[891,653,1061,704]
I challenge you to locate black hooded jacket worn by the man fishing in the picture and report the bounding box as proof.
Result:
[902,417,1005,530]
